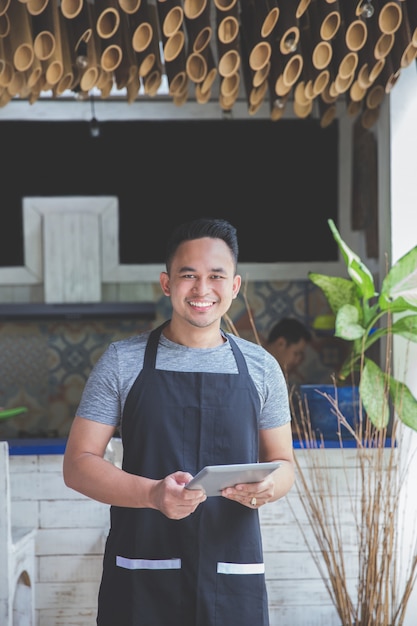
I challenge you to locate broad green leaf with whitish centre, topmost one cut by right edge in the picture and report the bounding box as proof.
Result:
[379,246,417,312]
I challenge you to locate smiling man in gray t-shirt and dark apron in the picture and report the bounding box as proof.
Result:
[64,219,294,626]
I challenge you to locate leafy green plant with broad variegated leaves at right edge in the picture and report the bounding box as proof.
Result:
[308,219,417,430]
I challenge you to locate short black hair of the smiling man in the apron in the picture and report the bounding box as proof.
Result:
[165,217,239,272]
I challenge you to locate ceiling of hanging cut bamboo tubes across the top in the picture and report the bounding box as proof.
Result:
[0,0,417,128]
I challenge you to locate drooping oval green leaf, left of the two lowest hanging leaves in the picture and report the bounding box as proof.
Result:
[359,359,390,428]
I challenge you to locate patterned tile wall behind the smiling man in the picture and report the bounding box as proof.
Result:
[0,281,343,439]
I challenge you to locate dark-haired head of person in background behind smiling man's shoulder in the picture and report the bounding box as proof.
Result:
[265,317,312,376]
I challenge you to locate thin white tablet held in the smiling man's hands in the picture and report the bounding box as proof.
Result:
[186,461,281,496]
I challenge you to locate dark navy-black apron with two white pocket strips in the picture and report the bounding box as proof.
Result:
[97,322,269,626]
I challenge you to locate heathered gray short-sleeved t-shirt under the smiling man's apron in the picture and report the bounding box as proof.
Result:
[76,331,291,429]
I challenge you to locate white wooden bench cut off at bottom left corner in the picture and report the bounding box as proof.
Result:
[0,441,36,626]
